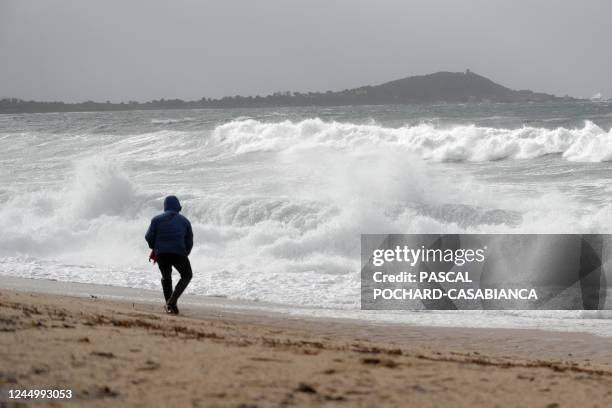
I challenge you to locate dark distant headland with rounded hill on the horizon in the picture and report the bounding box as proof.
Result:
[0,70,577,113]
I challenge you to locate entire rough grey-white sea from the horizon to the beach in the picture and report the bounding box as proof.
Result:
[0,102,612,335]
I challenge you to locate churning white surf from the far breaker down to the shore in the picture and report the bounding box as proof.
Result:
[0,115,612,322]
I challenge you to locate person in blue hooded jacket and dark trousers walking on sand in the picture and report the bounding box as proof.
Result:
[145,196,193,314]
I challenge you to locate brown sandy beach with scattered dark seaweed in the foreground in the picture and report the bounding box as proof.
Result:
[0,278,612,407]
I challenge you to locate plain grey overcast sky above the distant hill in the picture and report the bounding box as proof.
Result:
[0,0,612,101]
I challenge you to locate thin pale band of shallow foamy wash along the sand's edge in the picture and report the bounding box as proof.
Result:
[0,274,612,338]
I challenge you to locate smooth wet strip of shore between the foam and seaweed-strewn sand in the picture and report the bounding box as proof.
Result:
[0,275,612,366]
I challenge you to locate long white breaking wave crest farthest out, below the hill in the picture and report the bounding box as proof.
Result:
[211,119,612,162]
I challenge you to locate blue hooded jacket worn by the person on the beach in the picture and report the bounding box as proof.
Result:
[145,196,193,256]
